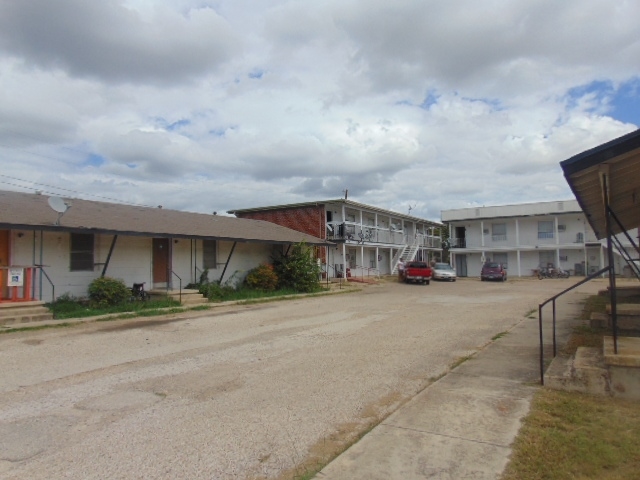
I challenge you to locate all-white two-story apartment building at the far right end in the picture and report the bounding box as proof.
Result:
[442,200,622,277]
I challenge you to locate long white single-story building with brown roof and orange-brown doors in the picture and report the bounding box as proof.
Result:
[0,191,330,302]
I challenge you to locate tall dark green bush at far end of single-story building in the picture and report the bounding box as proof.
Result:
[273,242,320,293]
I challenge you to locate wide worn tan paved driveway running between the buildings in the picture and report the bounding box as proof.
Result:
[0,279,606,479]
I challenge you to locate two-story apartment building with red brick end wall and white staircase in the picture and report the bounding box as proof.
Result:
[229,199,443,278]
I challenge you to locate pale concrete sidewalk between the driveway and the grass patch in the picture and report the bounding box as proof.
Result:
[315,301,581,480]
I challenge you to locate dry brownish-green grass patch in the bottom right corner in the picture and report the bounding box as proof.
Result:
[502,388,640,480]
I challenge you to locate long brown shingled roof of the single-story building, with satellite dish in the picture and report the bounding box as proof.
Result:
[0,191,332,245]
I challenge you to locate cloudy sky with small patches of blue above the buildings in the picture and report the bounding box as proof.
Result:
[0,0,640,220]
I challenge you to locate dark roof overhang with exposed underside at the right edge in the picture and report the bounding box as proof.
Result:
[560,130,640,239]
